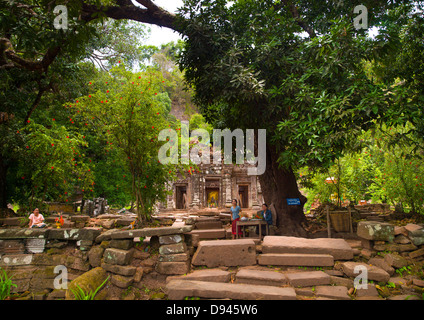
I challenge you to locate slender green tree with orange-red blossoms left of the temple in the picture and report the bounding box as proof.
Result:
[74,64,183,219]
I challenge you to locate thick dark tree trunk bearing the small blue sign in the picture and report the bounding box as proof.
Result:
[259,145,307,237]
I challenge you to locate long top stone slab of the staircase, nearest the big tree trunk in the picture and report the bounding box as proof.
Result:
[262,236,353,260]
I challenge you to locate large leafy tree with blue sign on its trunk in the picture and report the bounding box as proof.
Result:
[0,0,422,235]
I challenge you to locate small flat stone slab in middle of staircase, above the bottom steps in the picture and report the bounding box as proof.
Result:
[235,269,287,287]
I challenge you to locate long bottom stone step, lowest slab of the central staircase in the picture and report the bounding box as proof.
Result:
[166,280,296,300]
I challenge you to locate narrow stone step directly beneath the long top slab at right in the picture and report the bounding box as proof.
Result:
[258,249,334,267]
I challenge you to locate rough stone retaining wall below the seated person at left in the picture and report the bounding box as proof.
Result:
[0,226,194,299]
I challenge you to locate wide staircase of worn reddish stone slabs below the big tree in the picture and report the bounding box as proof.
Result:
[166,236,353,300]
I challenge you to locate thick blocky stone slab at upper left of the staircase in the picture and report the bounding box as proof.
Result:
[191,239,256,268]
